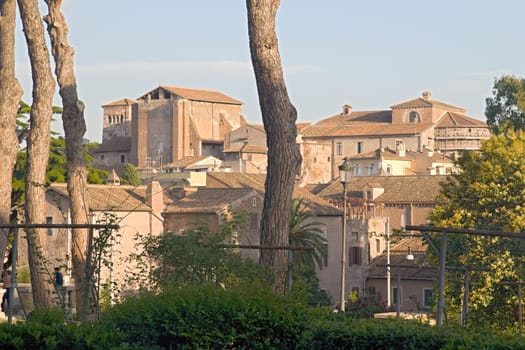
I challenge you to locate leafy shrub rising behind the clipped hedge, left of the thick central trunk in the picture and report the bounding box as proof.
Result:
[128,215,269,290]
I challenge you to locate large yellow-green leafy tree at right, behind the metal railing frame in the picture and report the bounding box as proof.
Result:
[431,129,525,327]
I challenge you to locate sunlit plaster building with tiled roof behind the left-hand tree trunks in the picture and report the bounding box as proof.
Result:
[35,182,164,292]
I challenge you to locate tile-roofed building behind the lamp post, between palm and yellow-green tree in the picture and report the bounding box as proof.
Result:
[317,175,446,306]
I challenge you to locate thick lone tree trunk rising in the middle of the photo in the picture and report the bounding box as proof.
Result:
[246,0,301,287]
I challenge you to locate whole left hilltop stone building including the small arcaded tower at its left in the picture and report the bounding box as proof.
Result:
[96,85,246,171]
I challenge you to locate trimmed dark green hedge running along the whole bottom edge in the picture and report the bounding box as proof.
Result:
[0,285,525,350]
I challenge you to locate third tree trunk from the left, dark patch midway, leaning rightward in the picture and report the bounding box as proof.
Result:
[44,0,91,319]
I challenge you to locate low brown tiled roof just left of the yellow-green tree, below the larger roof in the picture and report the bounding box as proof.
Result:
[368,237,438,280]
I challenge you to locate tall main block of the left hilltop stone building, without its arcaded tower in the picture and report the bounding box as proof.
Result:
[130,86,246,168]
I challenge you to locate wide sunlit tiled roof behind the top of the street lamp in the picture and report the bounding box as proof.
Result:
[319,175,446,204]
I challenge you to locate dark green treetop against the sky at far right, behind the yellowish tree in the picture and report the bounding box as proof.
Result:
[485,75,525,133]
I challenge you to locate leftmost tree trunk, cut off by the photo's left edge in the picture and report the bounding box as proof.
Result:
[0,0,22,261]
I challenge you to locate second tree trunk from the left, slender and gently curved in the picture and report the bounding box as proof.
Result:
[18,0,55,308]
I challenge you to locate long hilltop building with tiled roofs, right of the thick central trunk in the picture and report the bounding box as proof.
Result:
[301,92,490,184]
